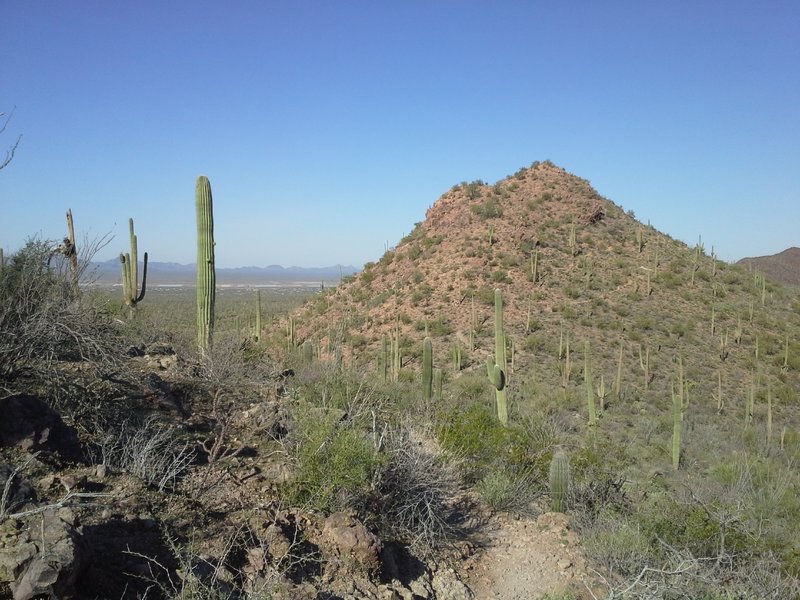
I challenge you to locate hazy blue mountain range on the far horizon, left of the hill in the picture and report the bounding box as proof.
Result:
[88,259,359,285]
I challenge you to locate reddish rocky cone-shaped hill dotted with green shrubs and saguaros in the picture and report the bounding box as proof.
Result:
[296,162,800,424]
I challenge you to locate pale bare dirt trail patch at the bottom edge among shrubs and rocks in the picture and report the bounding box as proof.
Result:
[465,513,587,600]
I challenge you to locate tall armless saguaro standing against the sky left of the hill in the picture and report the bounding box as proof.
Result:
[195,175,217,354]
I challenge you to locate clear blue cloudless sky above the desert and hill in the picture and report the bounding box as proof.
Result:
[0,0,800,266]
